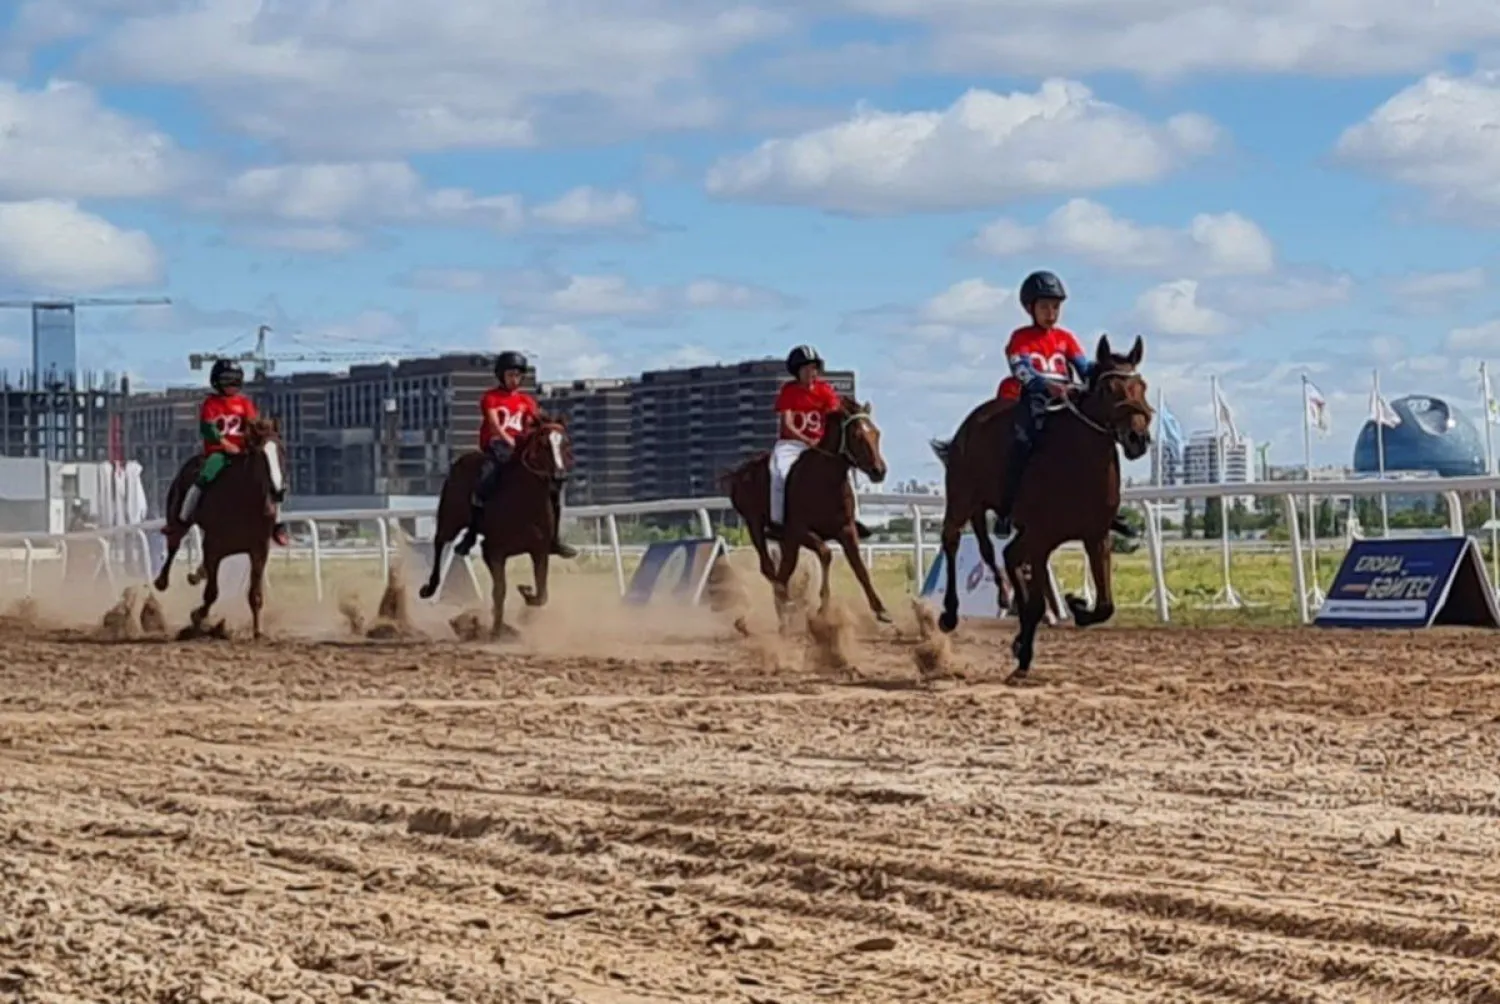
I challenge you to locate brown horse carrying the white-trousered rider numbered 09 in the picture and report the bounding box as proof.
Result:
[720,396,891,627]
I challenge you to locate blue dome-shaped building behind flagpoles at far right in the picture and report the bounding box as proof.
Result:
[1355,395,1487,477]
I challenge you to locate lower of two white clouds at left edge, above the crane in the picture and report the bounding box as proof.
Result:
[0,198,165,293]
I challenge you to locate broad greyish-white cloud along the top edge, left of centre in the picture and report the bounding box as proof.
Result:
[71,0,788,159]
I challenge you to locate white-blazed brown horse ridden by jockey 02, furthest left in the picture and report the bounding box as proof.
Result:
[155,417,287,638]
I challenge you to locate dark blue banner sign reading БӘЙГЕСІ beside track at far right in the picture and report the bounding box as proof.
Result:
[1314,537,1500,627]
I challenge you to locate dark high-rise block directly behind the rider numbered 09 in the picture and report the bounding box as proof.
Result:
[630,359,855,501]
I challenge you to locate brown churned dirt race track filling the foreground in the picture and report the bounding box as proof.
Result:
[0,626,1500,1004]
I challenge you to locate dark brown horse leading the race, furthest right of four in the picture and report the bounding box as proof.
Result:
[933,336,1152,678]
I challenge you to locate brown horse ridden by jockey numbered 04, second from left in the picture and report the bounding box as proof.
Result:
[419,417,573,638]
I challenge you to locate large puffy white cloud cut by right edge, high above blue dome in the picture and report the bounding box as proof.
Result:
[1338,74,1500,222]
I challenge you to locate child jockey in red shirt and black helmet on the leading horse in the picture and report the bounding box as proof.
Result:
[996,265,1094,536]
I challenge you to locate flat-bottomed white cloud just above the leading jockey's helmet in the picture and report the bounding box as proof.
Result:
[974,198,1277,275]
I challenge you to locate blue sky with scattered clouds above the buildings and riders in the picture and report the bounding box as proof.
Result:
[0,0,1500,480]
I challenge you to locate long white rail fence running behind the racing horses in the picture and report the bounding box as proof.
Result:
[0,477,1500,623]
